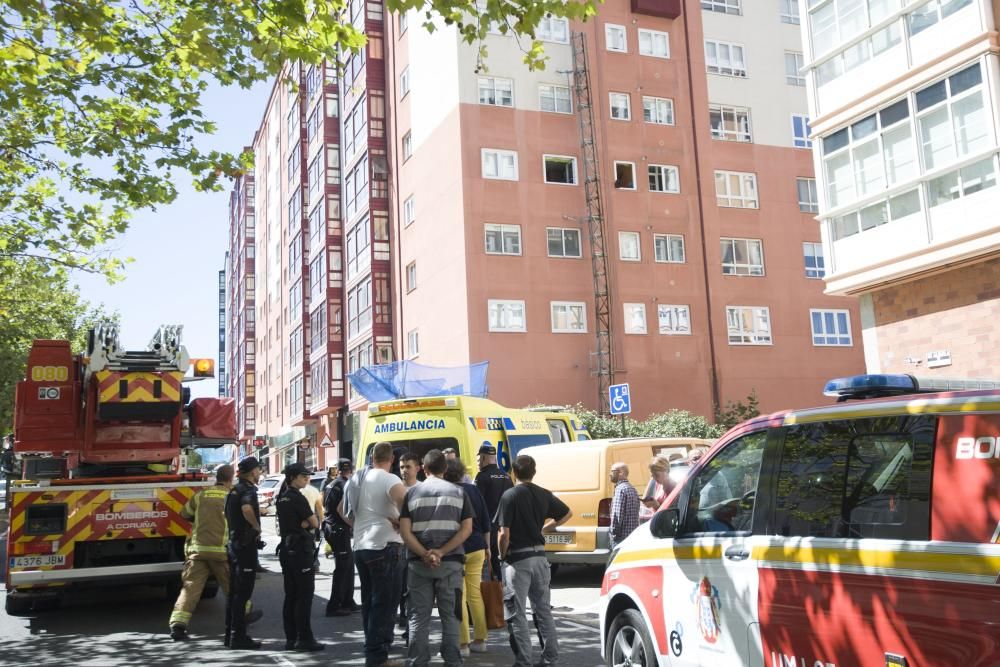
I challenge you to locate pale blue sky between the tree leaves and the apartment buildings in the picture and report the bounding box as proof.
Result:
[76,82,271,397]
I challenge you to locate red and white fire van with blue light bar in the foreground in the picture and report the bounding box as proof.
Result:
[601,375,1000,667]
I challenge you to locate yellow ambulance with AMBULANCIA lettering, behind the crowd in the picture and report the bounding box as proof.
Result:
[357,396,590,472]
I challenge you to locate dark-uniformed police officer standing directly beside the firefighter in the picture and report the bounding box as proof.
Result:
[226,456,264,650]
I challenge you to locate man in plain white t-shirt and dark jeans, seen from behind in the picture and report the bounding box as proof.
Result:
[338,442,405,667]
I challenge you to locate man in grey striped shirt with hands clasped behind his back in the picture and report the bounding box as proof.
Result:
[399,449,474,667]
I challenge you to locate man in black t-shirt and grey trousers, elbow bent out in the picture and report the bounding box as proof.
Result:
[496,454,573,667]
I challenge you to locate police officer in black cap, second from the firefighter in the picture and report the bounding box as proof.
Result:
[274,463,326,651]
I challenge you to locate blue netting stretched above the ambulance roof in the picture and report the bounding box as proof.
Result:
[347,361,490,403]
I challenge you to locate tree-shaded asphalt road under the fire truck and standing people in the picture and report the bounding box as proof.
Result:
[0,517,602,667]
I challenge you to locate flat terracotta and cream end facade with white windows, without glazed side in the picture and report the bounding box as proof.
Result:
[387,0,862,415]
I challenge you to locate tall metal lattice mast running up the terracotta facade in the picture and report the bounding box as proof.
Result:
[573,32,615,414]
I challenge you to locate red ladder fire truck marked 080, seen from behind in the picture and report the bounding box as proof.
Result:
[6,323,236,614]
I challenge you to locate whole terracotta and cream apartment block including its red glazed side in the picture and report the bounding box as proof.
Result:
[230,0,863,462]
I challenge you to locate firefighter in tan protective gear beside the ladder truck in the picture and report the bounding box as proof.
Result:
[170,465,263,640]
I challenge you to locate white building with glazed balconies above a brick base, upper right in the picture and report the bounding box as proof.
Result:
[802,0,1000,378]
